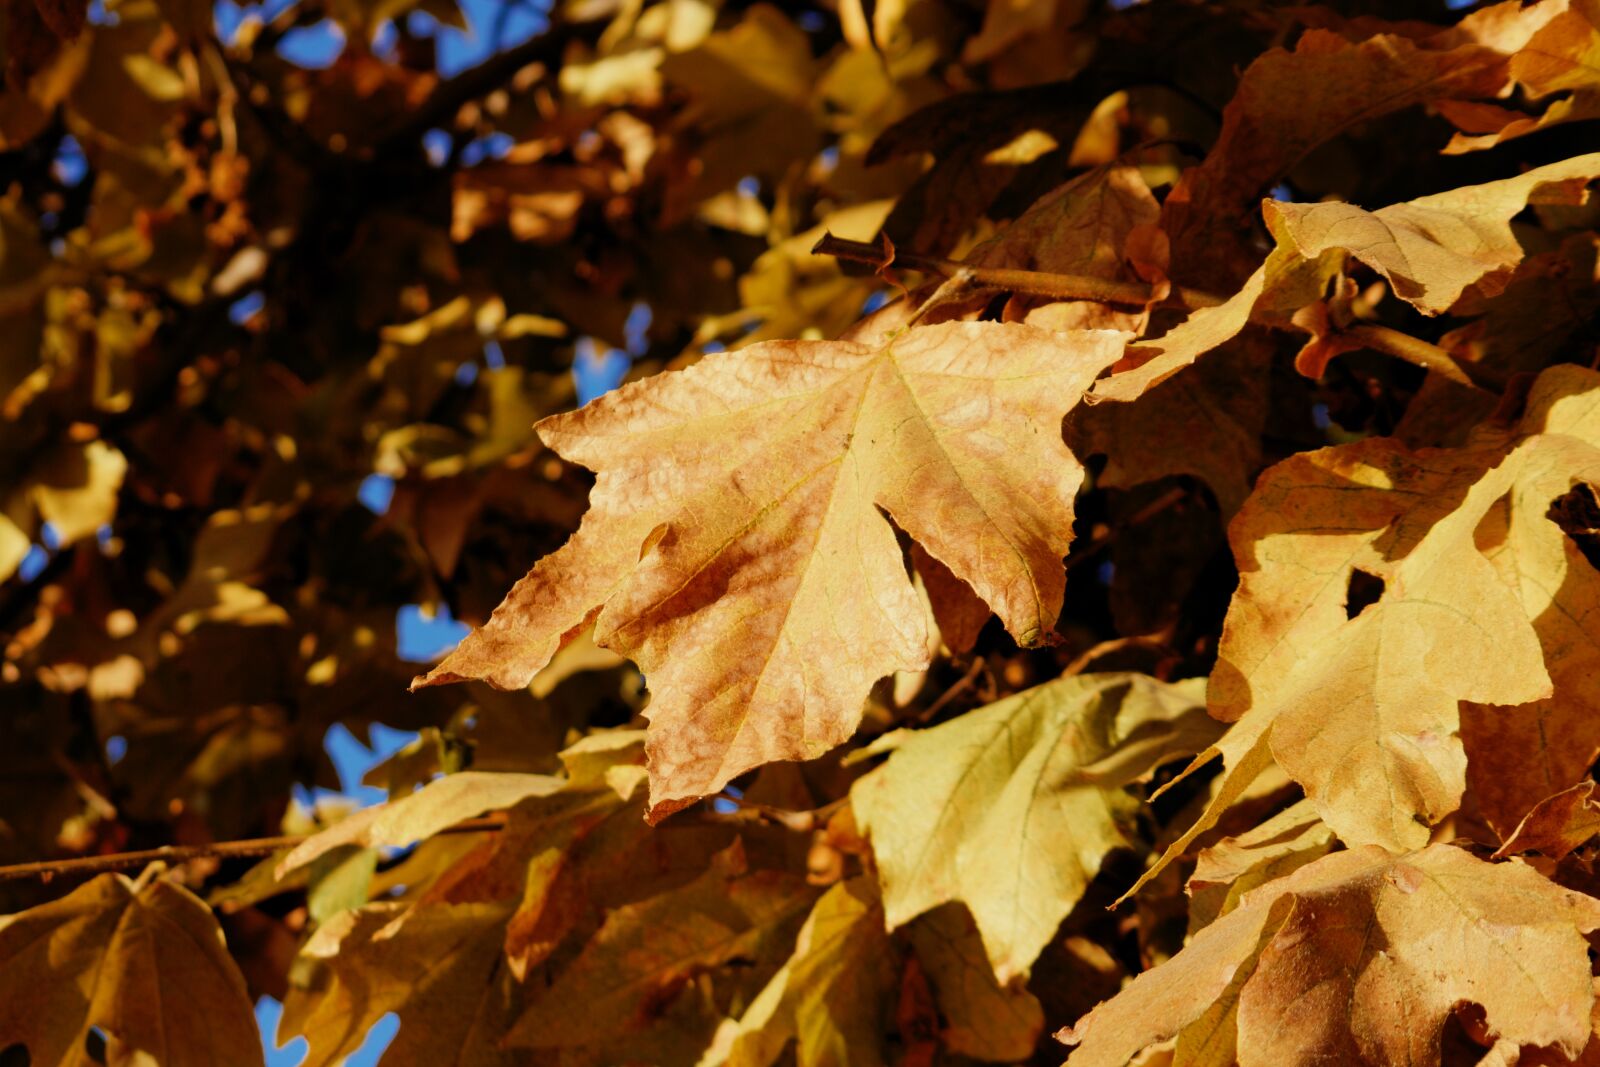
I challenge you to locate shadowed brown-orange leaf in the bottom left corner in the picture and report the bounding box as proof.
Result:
[0,875,261,1067]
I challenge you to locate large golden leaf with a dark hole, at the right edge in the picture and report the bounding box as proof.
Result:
[1210,366,1600,848]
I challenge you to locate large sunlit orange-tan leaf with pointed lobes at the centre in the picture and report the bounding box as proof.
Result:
[419,323,1122,817]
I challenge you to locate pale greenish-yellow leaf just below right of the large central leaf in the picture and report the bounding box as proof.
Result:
[851,673,1216,984]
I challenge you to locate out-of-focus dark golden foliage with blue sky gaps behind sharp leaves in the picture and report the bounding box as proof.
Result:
[0,0,1579,1062]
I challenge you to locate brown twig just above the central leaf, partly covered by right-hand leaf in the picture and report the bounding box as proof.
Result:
[811,234,1506,392]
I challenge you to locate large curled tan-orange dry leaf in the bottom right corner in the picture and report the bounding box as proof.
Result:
[1058,845,1600,1067]
